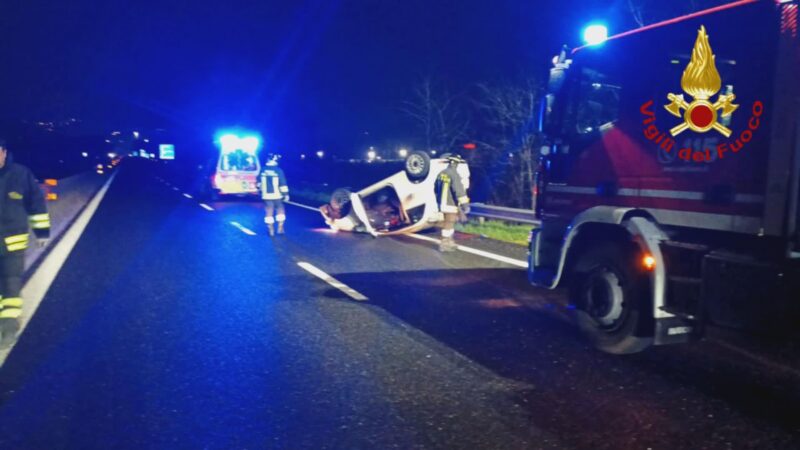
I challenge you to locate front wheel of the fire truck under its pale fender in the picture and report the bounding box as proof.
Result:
[570,243,653,355]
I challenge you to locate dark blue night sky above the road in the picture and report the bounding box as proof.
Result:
[0,0,632,152]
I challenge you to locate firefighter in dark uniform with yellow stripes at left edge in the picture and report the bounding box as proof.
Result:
[0,139,50,348]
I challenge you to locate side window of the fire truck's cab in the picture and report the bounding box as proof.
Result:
[575,67,620,134]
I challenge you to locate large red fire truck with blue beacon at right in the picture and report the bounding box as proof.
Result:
[528,0,800,354]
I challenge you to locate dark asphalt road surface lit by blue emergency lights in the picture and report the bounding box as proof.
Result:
[0,163,800,449]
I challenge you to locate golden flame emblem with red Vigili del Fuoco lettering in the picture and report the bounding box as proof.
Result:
[639,26,764,162]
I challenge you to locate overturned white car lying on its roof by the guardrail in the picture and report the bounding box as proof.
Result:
[320,152,470,236]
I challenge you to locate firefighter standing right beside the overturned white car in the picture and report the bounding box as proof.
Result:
[436,155,469,252]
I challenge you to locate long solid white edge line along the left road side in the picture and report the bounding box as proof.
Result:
[0,172,119,366]
